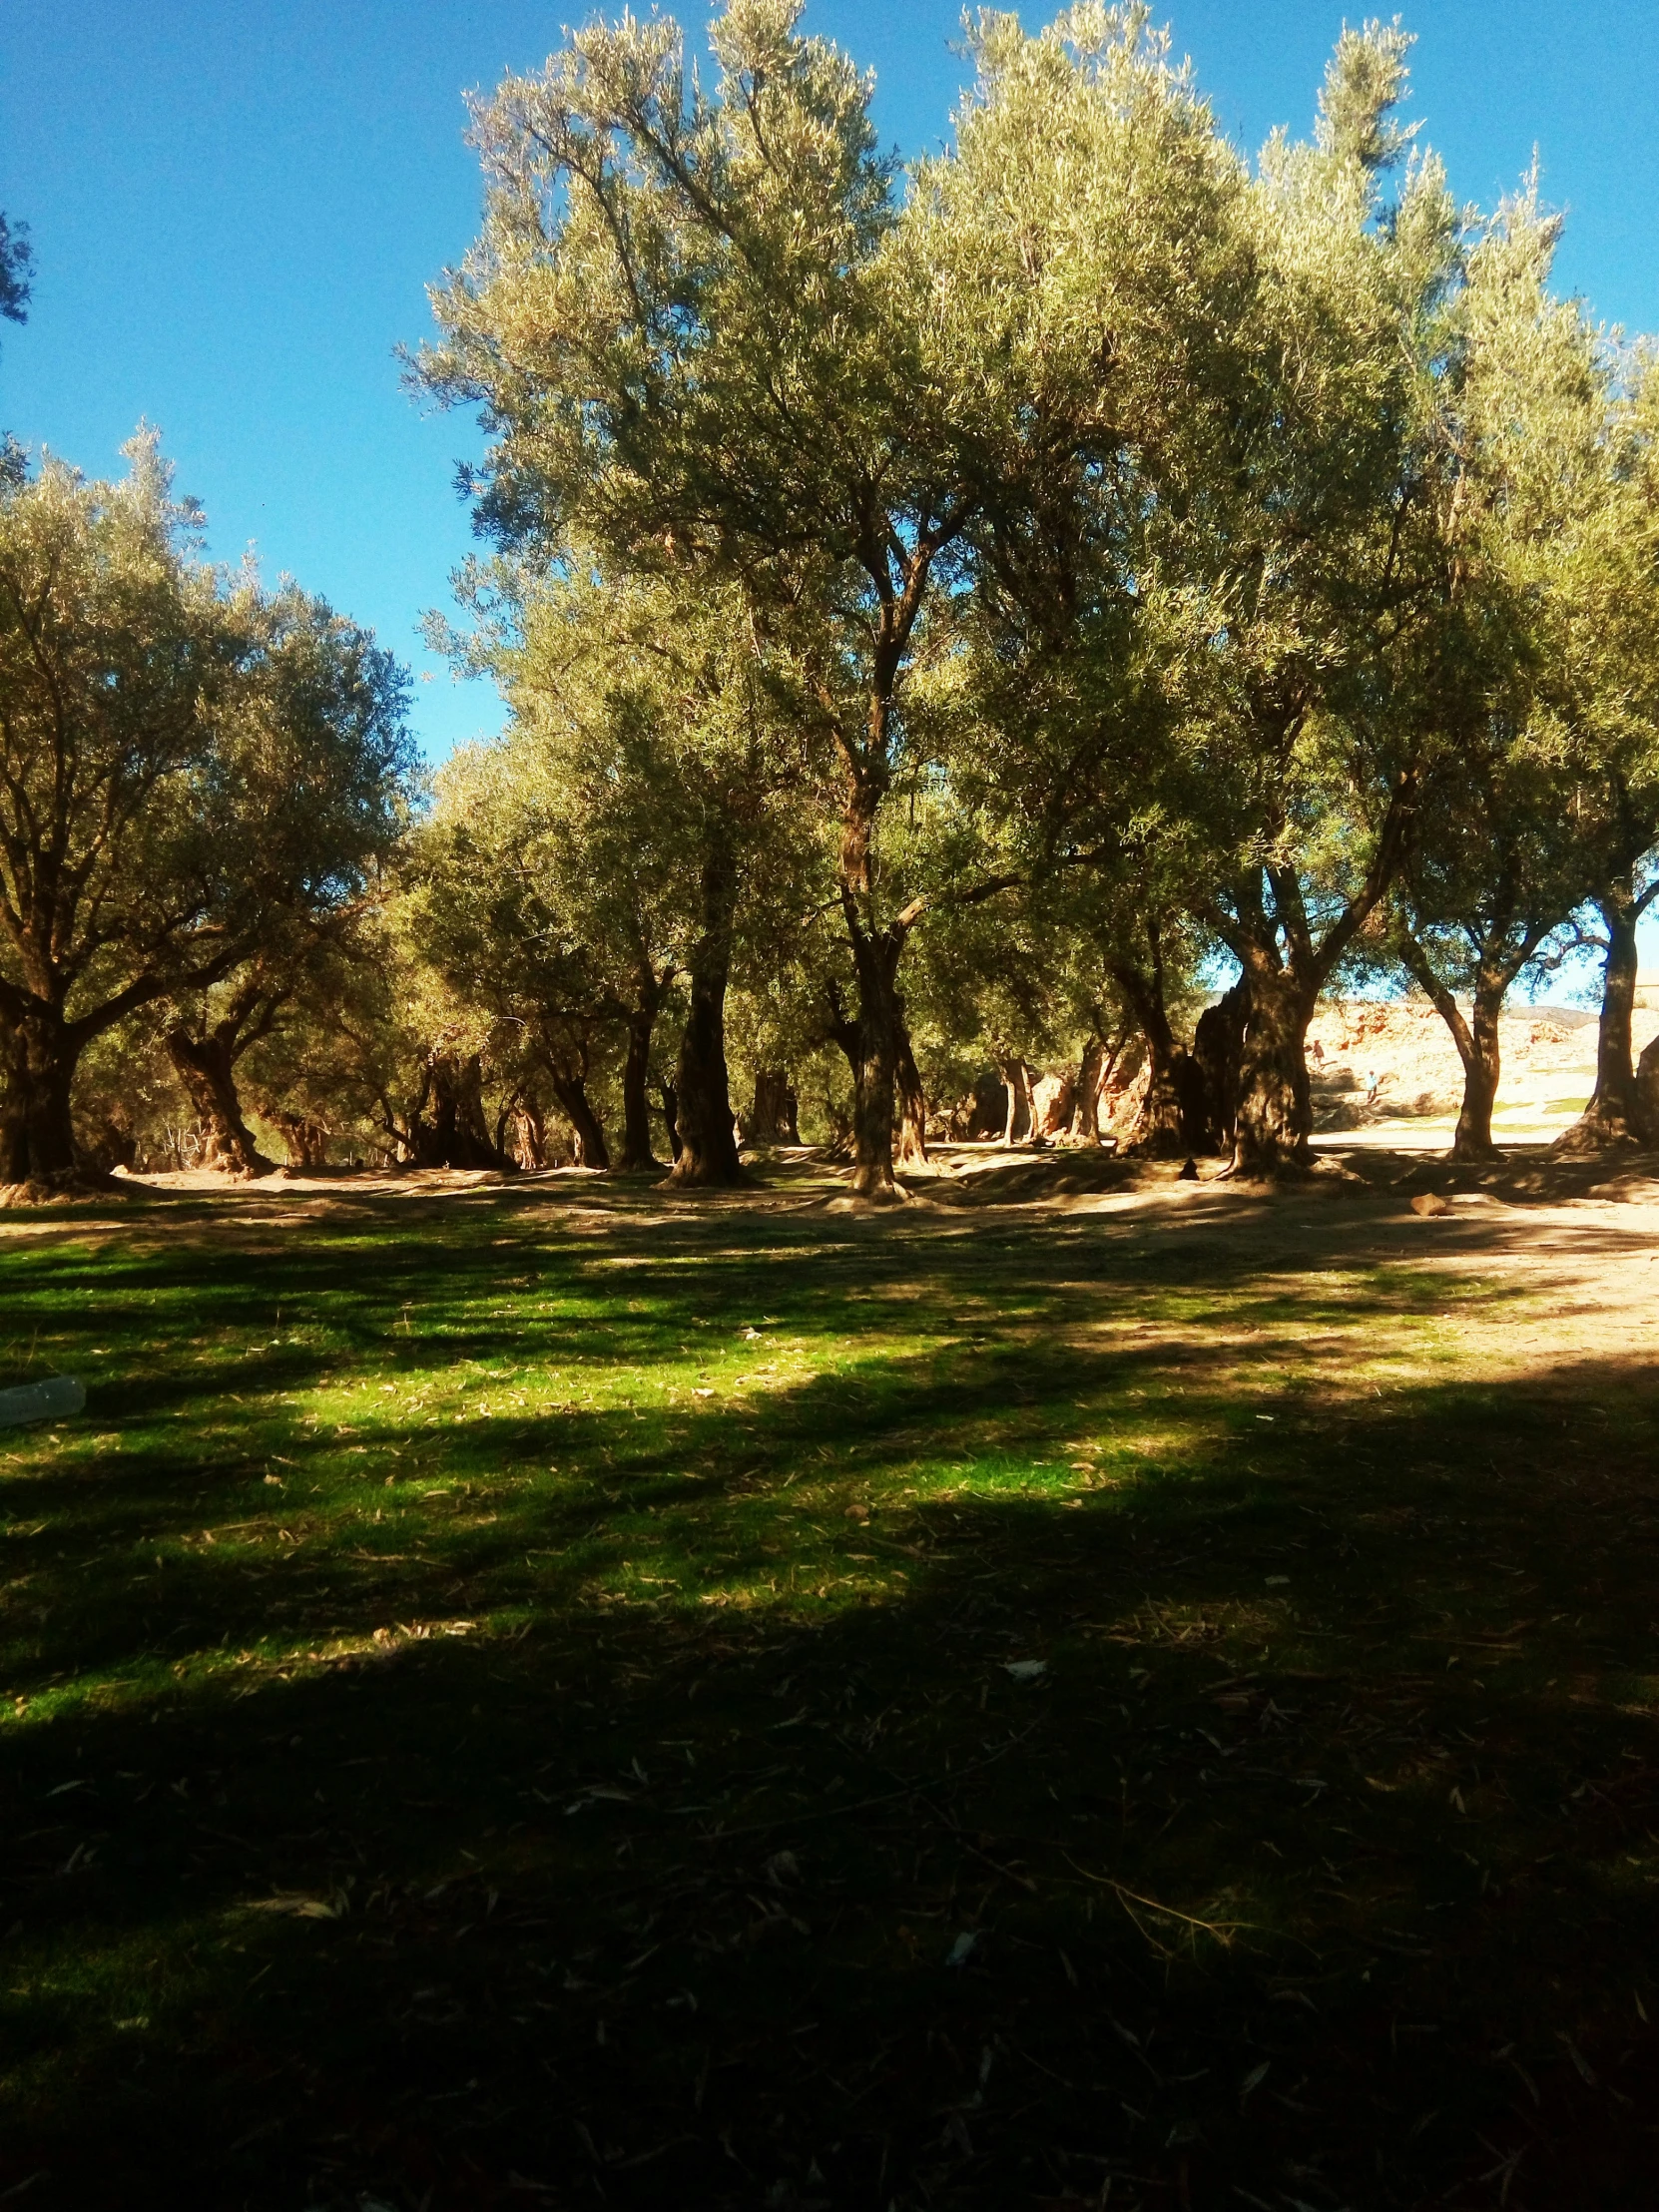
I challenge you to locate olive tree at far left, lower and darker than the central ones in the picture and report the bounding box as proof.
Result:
[0,433,409,1186]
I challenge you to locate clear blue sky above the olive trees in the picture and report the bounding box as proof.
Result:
[0,0,1659,757]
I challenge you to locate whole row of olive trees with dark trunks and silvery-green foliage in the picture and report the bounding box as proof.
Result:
[0,0,1659,1199]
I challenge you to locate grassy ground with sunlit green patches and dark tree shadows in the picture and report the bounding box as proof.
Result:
[0,1161,1659,2212]
